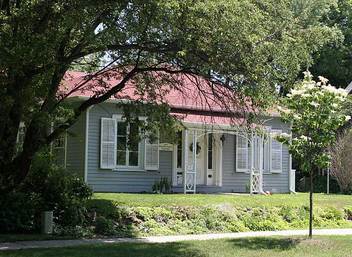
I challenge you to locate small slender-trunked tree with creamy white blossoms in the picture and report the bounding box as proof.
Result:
[278,72,351,237]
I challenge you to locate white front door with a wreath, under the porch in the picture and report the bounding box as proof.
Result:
[188,133,206,185]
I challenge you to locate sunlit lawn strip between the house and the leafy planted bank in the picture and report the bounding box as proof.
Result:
[94,193,352,209]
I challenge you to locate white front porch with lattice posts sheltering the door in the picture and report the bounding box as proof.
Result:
[172,123,269,194]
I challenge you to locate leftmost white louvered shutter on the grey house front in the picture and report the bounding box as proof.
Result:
[100,118,116,169]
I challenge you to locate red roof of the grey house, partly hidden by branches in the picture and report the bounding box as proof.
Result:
[59,71,251,125]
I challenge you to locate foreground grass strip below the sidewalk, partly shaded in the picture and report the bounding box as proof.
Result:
[0,236,352,257]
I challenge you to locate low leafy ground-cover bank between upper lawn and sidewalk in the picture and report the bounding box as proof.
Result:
[86,200,349,236]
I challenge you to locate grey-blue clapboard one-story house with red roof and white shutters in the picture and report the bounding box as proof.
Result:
[54,72,295,193]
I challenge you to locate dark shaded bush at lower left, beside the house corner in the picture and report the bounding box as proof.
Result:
[0,152,92,234]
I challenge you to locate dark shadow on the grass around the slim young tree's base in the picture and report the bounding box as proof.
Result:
[231,237,301,251]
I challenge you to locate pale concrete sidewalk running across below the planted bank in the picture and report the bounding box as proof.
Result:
[0,229,352,251]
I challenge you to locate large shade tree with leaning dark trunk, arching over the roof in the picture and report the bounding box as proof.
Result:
[0,0,336,192]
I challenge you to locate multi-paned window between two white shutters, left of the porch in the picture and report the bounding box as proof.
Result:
[116,121,139,167]
